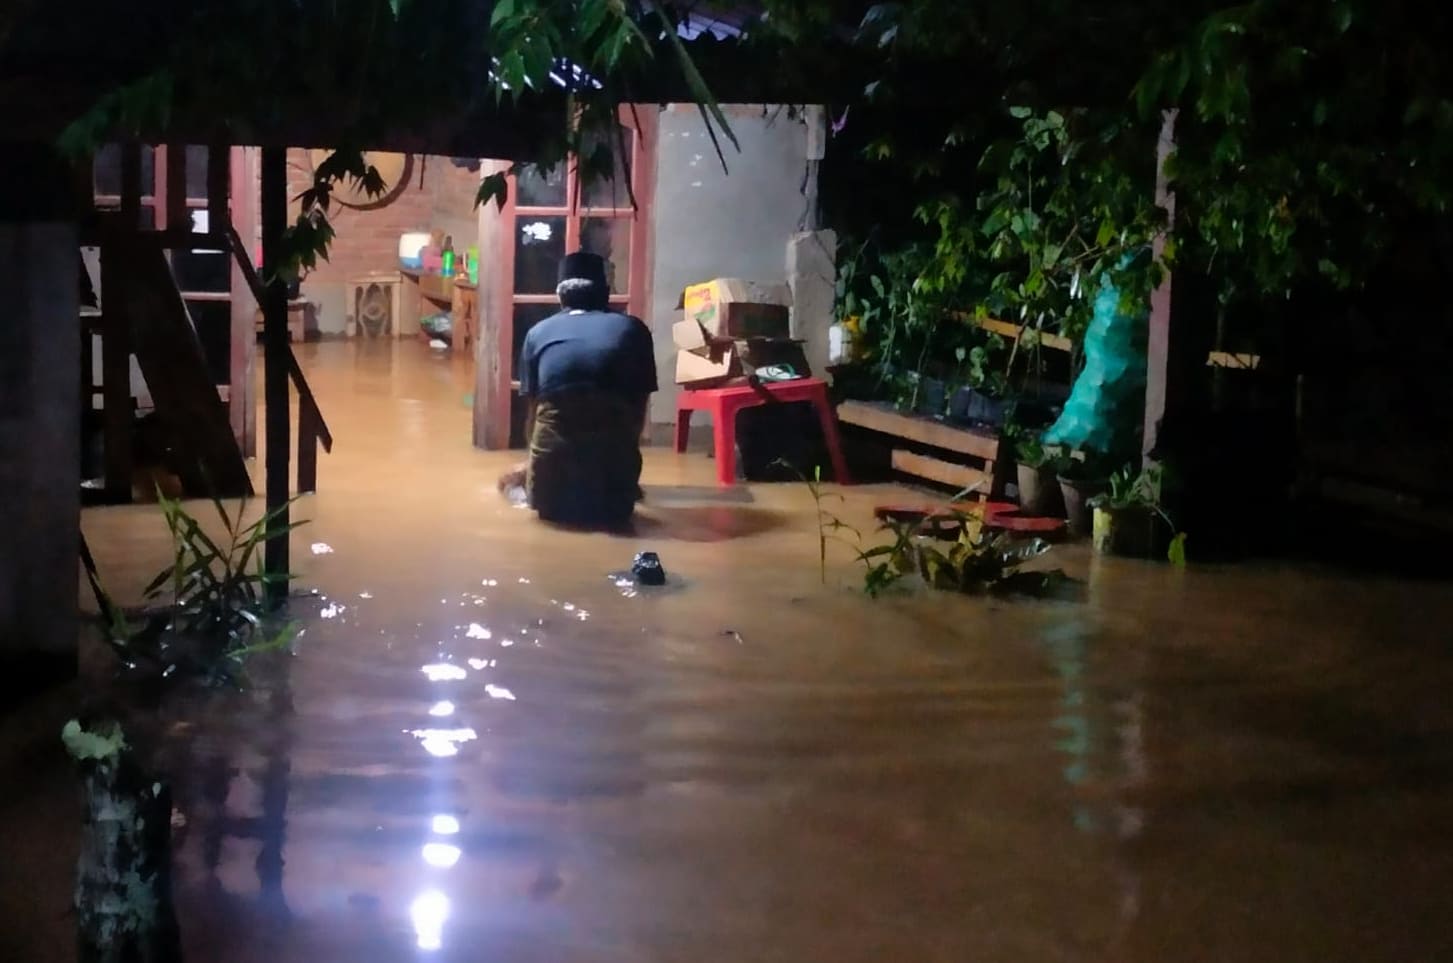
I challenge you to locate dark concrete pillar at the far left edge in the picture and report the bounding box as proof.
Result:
[0,145,81,704]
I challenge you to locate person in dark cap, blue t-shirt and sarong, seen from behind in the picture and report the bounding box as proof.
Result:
[501,251,657,527]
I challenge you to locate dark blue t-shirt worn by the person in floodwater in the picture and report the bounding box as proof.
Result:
[519,311,657,398]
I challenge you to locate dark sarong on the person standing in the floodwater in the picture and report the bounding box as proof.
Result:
[526,389,641,526]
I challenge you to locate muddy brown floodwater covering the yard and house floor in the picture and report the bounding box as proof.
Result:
[0,341,1453,963]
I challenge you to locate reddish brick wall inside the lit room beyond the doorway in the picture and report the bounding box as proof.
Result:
[288,148,479,334]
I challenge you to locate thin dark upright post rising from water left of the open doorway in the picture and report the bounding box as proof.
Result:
[262,147,291,603]
